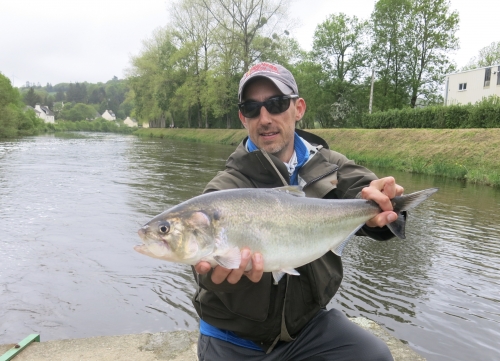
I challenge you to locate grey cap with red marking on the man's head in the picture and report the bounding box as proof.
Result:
[238,63,299,102]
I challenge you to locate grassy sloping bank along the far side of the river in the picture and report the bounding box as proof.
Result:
[135,128,500,187]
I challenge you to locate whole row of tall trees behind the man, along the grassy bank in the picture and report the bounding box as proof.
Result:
[128,0,459,128]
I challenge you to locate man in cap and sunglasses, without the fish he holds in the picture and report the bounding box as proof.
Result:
[193,63,403,361]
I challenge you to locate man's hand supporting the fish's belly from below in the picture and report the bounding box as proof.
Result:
[194,248,264,285]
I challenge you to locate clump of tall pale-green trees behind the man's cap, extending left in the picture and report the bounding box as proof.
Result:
[128,0,296,127]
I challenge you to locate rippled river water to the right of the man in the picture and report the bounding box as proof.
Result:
[331,169,500,360]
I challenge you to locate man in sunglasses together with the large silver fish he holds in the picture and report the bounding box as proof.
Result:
[135,63,437,361]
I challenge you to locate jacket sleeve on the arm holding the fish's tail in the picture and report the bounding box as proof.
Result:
[330,151,398,241]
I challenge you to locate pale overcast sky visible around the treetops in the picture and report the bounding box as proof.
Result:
[0,0,500,86]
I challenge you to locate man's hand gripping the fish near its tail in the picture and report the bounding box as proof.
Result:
[361,177,404,227]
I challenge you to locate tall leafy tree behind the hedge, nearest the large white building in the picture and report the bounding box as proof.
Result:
[372,0,458,108]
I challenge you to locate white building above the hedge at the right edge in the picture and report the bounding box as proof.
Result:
[444,65,500,105]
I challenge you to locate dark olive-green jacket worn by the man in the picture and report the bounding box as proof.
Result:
[193,130,393,352]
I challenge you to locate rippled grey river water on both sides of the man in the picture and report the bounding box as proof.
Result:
[0,133,500,360]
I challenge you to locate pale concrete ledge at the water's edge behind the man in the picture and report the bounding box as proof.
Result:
[0,317,425,361]
